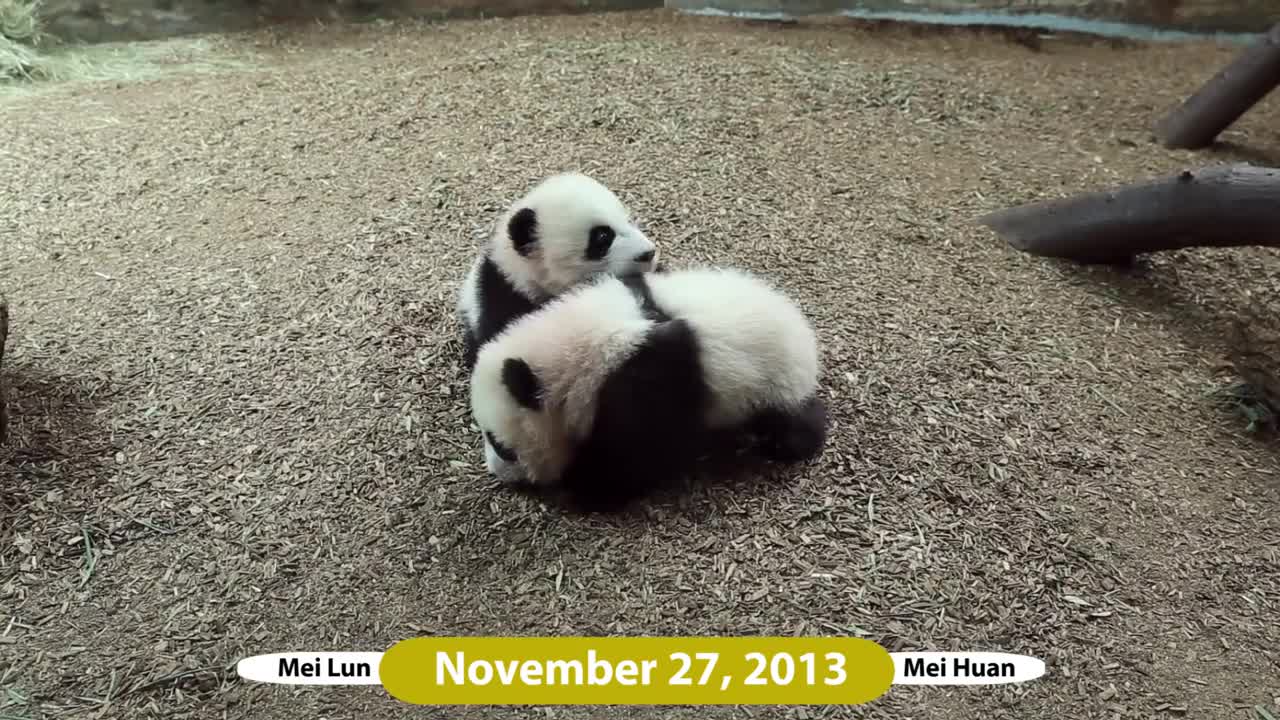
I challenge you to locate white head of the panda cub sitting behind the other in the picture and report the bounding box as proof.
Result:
[493,173,658,297]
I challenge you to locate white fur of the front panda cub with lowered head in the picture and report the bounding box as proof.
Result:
[471,268,820,484]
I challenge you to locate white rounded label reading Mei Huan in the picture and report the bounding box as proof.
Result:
[890,652,1044,685]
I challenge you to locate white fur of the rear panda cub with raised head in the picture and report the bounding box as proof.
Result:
[458,173,658,328]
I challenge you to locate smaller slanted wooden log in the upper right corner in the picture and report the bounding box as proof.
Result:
[1156,23,1280,150]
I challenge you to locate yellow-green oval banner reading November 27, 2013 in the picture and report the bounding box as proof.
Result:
[378,637,893,705]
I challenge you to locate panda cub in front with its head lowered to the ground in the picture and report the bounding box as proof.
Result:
[471,268,827,510]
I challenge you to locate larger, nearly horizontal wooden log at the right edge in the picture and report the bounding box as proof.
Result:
[978,164,1280,263]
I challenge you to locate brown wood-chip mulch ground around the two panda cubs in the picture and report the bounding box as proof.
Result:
[0,13,1280,719]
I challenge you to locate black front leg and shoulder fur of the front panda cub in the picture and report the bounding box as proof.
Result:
[561,320,710,511]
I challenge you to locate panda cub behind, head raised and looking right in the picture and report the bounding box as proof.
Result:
[458,173,658,369]
